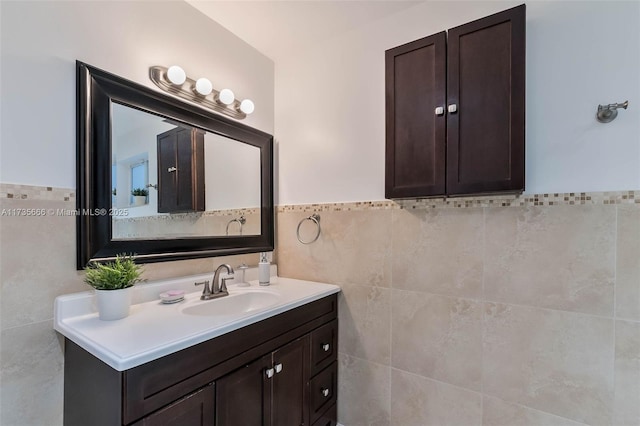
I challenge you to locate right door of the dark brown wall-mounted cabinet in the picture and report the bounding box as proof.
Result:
[447,5,525,194]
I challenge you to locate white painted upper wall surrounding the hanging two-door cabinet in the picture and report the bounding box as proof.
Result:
[275,1,640,205]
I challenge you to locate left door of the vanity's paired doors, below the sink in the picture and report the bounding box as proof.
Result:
[215,355,271,426]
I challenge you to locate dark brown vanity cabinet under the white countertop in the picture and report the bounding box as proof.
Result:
[64,294,338,426]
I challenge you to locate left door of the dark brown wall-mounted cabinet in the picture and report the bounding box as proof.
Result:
[385,32,446,198]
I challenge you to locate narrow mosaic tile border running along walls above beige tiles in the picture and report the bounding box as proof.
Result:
[0,183,640,211]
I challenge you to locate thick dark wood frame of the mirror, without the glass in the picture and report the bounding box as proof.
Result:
[76,61,274,269]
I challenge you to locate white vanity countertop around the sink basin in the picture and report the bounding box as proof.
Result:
[54,274,340,371]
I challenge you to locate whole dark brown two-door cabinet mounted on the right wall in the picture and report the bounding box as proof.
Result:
[385,5,525,198]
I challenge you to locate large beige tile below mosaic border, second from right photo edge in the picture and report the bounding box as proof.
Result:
[484,206,615,316]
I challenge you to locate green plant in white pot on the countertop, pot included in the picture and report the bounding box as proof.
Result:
[84,254,142,321]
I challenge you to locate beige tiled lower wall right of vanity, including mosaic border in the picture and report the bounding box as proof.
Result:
[276,191,640,426]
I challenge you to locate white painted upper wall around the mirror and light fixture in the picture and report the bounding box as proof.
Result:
[0,1,274,188]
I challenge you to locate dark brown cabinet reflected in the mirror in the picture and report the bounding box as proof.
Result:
[157,127,205,213]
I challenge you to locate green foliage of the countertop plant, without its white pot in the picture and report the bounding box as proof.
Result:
[84,254,142,290]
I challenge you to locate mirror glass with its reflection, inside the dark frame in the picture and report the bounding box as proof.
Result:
[111,102,261,240]
